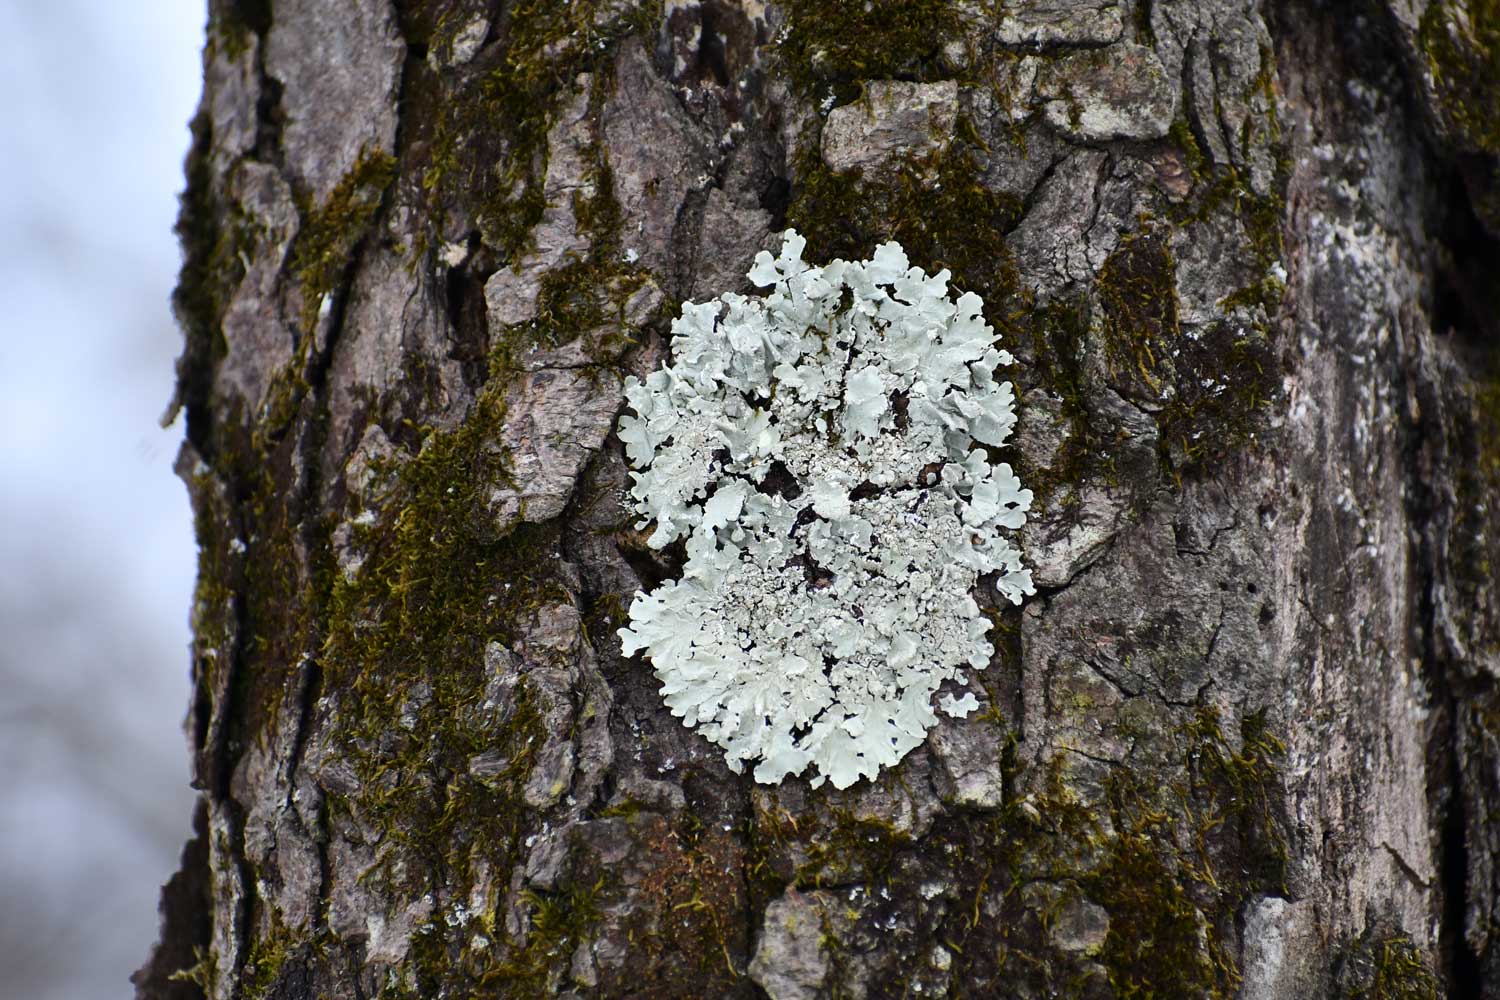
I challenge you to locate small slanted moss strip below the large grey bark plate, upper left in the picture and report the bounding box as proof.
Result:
[291,148,396,331]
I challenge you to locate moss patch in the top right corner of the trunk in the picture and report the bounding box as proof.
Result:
[1418,0,1500,156]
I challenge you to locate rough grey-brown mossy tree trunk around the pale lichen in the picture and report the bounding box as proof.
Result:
[135,0,1500,1000]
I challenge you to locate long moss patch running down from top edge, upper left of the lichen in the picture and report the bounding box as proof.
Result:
[423,0,662,259]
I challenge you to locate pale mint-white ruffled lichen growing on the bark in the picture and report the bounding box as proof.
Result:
[620,231,1034,789]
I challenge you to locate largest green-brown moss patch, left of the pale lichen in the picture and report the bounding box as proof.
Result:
[324,387,567,821]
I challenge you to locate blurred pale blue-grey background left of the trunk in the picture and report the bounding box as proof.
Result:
[0,0,206,1000]
